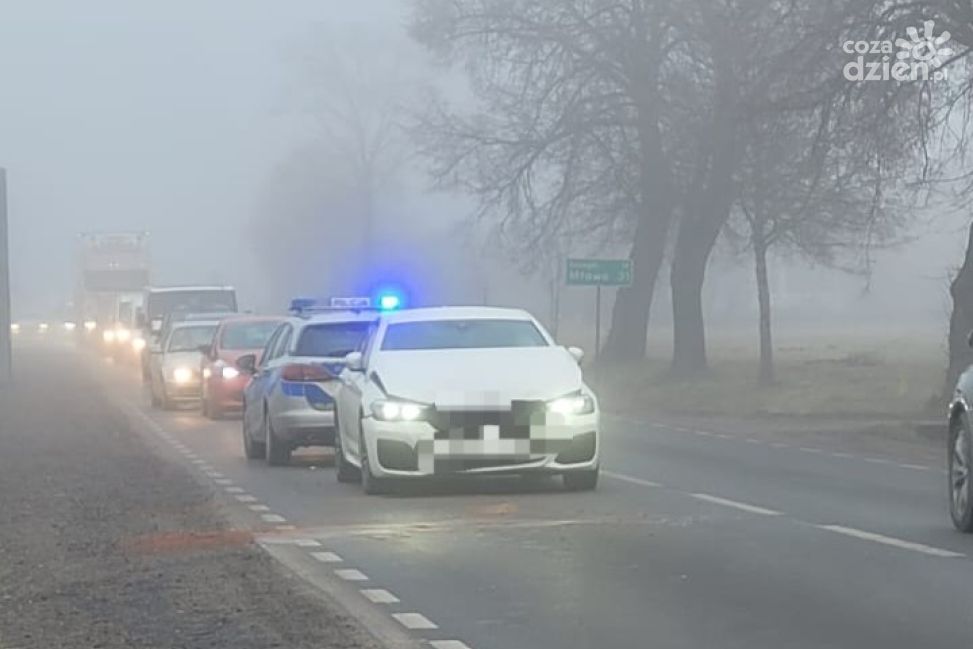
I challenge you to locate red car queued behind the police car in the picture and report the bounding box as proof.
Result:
[200,316,283,419]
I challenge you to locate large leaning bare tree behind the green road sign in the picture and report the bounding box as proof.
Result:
[413,0,678,359]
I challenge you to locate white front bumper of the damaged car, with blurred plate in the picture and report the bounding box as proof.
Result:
[362,412,600,478]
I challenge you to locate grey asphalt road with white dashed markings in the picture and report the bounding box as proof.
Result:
[17,340,973,649]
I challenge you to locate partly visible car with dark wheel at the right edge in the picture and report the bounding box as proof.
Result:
[946,333,973,533]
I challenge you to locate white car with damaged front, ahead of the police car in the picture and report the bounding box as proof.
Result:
[335,307,599,494]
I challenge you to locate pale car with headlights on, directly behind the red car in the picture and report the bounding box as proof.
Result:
[149,320,220,410]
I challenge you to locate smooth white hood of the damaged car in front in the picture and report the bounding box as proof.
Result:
[370,347,582,407]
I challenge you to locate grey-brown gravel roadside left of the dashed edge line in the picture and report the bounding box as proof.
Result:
[0,352,376,649]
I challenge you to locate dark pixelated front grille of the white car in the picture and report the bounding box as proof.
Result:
[429,401,546,440]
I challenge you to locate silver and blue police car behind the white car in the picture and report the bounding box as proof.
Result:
[237,309,378,465]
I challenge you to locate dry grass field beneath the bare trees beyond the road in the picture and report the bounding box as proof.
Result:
[586,332,945,418]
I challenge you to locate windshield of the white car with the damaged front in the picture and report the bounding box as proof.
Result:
[382,319,547,351]
